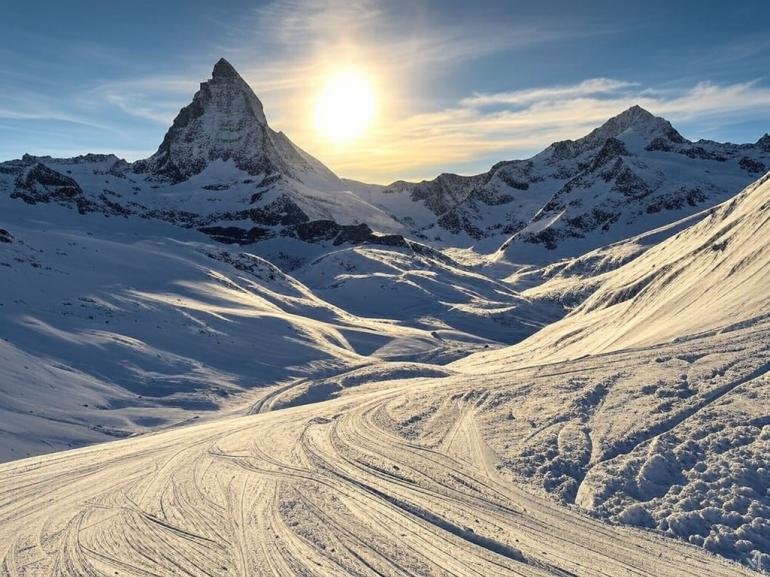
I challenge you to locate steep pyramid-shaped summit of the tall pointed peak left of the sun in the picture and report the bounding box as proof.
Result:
[136,58,339,184]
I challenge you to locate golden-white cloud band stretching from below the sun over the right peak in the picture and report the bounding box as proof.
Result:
[308,78,770,182]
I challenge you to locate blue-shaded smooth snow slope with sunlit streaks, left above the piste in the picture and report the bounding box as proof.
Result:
[0,199,487,460]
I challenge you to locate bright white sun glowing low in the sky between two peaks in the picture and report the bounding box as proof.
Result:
[315,70,377,144]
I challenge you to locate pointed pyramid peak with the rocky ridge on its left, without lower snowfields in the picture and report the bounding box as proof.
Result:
[0,59,406,266]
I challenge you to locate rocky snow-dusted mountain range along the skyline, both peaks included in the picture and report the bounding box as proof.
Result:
[0,59,770,266]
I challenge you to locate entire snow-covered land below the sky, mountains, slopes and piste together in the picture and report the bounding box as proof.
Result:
[0,60,770,576]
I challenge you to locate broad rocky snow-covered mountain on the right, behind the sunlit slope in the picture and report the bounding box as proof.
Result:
[362,106,770,264]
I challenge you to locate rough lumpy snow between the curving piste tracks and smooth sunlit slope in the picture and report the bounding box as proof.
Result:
[436,319,770,574]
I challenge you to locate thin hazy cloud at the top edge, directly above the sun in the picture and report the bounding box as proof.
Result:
[212,0,607,90]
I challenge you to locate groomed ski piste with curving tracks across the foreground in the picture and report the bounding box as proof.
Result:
[0,362,750,577]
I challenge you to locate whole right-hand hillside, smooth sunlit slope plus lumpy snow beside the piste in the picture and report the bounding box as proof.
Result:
[451,170,770,571]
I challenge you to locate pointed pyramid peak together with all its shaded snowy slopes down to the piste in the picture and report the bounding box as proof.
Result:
[0,60,561,460]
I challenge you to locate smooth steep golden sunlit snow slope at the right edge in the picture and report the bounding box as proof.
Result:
[464,175,770,366]
